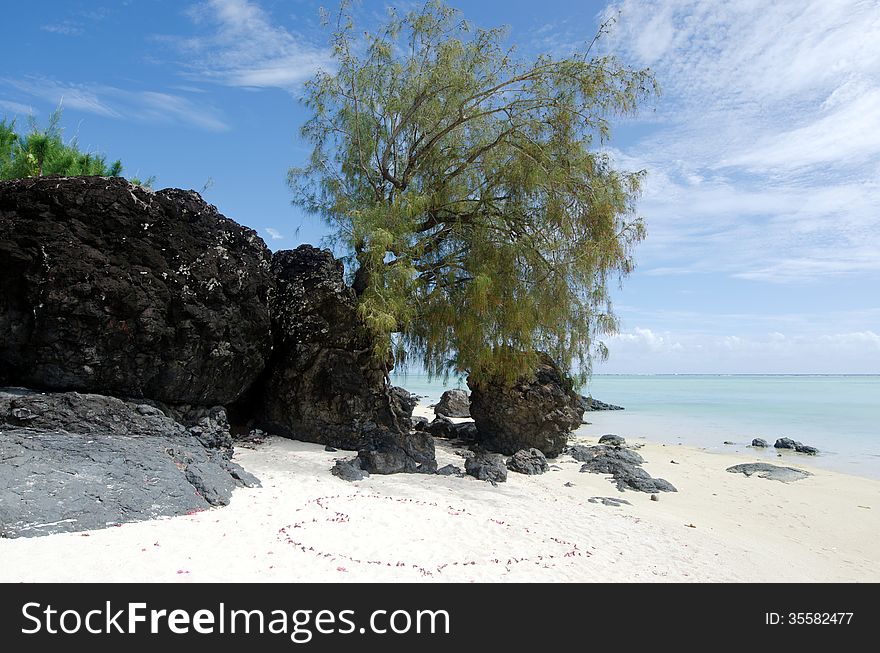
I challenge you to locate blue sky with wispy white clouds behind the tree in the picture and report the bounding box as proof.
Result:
[0,0,880,373]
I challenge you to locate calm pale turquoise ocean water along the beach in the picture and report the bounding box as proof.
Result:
[392,374,880,478]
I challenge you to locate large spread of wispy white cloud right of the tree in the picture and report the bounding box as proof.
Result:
[606,0,880,282]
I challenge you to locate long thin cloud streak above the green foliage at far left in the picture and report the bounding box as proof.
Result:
[0,77,229,131]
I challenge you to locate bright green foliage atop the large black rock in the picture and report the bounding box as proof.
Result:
[0,107,148,186]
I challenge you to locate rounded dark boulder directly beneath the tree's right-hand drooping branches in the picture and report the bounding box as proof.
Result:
[468,354,583,458]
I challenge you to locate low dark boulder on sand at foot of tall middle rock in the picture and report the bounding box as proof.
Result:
[358,428,437,474]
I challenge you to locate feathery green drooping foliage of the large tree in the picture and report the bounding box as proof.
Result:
[288,0,657,381]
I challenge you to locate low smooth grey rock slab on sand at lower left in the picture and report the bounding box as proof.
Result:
[0,389,259,537]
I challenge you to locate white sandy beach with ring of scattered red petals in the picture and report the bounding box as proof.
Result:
[0,407,880,582]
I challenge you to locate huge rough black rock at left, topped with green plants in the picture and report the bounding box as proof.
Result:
[0,177,274,406]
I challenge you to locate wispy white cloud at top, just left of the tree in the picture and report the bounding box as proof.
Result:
[159,0,330,90]
